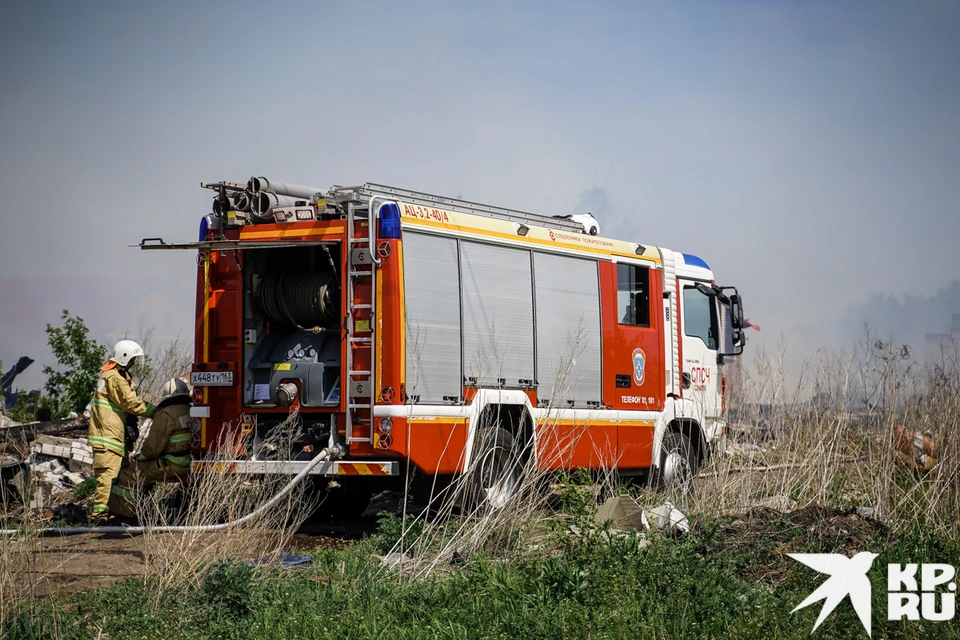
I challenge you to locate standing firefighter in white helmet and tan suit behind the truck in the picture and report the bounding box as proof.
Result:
[87,340,155,523]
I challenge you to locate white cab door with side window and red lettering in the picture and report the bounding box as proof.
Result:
[679,279,721,429]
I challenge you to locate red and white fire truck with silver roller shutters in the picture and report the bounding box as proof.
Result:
[141,178,745,502]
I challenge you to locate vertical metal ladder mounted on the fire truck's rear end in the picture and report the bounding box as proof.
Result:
[341,199,380,445]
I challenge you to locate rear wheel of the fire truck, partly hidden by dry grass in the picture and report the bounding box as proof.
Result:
[469,427,523,511]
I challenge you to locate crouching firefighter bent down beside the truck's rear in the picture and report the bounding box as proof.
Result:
[109,378,190,518]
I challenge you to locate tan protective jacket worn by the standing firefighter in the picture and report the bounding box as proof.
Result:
[87,368,154,455]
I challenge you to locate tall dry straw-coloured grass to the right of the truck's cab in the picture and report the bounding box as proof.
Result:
[681,333,960,532]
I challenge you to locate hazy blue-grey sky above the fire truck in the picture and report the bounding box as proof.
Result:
[0,0,960,387]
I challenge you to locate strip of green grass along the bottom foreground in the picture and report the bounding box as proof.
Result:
[3,514,960,640]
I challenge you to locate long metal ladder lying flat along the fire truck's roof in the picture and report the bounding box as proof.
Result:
[327,182,584,233]
